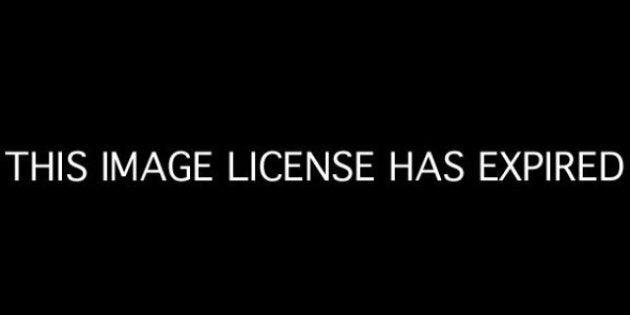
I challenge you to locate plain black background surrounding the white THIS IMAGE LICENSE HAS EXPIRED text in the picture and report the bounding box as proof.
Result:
[0,4,628,308]
